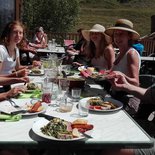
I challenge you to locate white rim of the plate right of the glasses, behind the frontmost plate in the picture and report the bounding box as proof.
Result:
[79,96,123,112]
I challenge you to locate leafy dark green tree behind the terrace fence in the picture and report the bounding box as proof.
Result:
[22,0,79,32]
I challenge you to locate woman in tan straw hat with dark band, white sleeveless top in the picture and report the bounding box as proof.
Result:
[105,19,141,99]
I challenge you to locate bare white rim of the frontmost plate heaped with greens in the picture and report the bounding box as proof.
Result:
[32,119,85,141]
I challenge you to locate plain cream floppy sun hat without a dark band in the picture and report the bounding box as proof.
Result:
[82,24,111,42]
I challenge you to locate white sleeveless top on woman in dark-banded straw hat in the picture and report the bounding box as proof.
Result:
[112,47,141,74]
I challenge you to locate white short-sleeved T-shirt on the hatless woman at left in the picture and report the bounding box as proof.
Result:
[0,45,19,75]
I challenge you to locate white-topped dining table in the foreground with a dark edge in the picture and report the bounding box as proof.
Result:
[0,76,153,154]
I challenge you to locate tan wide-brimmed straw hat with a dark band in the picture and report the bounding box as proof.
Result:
[105,19,140,40]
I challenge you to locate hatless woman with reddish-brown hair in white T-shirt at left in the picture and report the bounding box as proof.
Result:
[0,21,39,91]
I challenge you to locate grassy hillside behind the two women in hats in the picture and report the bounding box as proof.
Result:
[74,0,155,36]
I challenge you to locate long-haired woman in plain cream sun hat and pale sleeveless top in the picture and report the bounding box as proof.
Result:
[82,24,115,69]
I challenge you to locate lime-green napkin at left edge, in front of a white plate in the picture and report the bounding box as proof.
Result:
[0,114,22,122]
